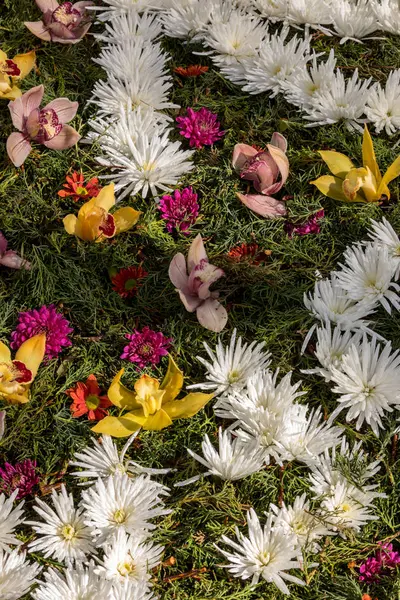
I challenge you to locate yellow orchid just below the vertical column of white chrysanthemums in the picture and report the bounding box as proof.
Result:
[63,183,141,242]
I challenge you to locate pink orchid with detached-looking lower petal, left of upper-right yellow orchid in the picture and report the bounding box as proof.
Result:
[232,132,289,218]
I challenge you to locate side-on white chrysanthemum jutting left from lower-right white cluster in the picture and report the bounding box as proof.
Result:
[178,427,265,485]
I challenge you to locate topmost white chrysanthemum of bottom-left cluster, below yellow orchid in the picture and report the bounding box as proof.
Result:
[69,431,170,485]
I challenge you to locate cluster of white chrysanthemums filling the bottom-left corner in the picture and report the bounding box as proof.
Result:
[0,434,170,600]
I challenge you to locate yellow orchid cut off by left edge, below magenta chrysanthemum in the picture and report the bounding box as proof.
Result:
[0,333,46,404]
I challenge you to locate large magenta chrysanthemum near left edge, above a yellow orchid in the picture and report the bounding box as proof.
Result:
[11,304,73,360]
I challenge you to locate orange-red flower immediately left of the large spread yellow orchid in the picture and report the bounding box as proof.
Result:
[66,375,112,421]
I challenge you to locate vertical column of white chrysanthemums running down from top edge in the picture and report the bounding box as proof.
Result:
[87,7,193,199]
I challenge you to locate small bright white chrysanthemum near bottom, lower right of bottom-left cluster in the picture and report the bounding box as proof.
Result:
[95,529,164,588]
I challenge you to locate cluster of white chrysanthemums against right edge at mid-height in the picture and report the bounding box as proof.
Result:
[303,219,400,436]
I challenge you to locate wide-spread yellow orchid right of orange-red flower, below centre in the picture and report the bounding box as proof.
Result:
[92,356,213,437]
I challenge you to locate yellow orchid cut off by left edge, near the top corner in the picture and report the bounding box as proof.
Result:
[0,50,36,100]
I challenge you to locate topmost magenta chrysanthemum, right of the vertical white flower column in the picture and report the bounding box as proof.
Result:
[176,107,225,148]
